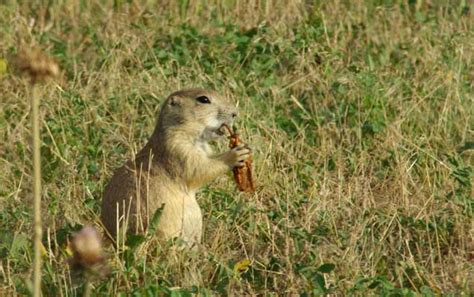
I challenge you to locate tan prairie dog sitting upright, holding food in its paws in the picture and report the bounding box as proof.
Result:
[102,88,250,245]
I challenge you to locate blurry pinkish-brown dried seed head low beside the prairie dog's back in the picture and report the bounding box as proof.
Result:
[71,227,104,267]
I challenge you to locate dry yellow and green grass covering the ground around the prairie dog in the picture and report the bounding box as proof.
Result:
[0,0,474,296]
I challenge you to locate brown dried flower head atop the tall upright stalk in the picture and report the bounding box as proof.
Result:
[13,48,59,83]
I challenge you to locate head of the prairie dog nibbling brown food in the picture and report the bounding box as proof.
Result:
[158,88,237,141]
